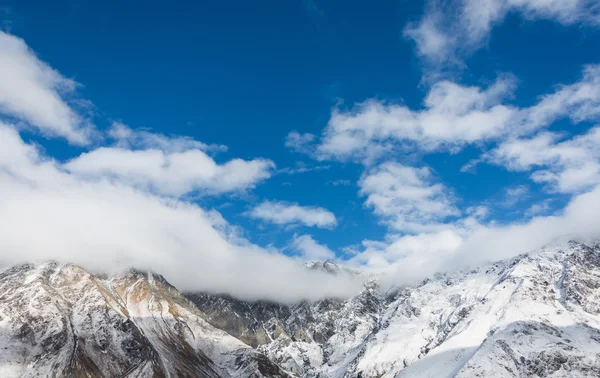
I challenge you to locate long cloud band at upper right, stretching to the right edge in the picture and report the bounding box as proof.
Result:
[309,65,600,165]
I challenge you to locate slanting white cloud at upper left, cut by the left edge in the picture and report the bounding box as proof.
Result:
[0,31,94,145]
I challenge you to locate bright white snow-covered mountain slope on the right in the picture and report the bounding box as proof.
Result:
[357,243,600,377]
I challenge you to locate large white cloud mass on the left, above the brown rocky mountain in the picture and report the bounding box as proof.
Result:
[0,33,360,301]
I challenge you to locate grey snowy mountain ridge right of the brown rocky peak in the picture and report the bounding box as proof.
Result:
[187,242,600,378]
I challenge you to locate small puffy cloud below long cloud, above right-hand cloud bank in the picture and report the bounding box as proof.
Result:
[358,162,460,232]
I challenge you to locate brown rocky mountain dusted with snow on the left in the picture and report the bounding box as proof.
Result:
[0,263,287,378]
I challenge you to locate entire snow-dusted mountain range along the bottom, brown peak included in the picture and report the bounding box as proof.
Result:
[0,242,600,378]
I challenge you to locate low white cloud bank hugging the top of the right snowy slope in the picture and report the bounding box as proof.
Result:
[347,186,600,287]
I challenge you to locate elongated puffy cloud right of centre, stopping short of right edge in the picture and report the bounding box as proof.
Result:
[315,75,517,163]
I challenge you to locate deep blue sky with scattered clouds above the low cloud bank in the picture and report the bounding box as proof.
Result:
[0,0,600,302]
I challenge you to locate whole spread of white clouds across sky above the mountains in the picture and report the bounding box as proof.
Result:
[0,0,600,302]
